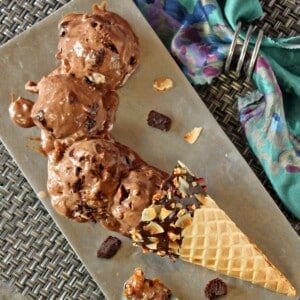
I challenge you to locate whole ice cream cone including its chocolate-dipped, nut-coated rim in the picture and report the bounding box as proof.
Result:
[131,163,296,296]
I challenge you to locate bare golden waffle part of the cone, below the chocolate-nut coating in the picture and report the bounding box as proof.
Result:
[179,196,296,296]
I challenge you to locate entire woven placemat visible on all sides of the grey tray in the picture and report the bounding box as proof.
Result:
[0,0,300,299]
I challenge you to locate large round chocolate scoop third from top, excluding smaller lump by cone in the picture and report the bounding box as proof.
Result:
[47,139,133,222]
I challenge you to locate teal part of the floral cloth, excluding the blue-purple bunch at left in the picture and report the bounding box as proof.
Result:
[223,1,300,219]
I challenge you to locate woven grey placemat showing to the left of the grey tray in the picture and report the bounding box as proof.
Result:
[0,0,104,300]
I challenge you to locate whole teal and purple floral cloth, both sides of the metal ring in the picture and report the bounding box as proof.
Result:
[134,0,300,219]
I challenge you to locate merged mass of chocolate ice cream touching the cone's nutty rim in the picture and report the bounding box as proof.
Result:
[47,138,167,235]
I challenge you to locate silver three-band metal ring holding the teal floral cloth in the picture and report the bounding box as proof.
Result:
[225,22,264,81]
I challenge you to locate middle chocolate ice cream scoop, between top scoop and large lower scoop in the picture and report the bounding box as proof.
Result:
[31,74,119,152]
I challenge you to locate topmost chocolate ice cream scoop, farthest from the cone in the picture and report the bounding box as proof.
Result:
[56,5,139,89]
